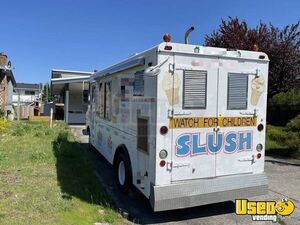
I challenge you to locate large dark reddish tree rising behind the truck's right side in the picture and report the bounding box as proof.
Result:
[205,17,300,97]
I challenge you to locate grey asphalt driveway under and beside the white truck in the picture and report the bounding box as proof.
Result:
[73,127,300,225]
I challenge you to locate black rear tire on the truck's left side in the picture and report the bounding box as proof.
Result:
[114,153,132,194]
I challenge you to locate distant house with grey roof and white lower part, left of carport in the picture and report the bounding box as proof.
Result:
[13,83,43,106]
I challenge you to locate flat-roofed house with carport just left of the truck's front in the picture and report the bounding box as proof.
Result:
[50,69,92,124]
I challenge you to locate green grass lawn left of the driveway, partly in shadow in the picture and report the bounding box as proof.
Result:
[0,122,123,225]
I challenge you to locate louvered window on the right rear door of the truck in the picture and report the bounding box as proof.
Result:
[227,73,248,109]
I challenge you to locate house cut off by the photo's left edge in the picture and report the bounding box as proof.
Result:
[0,53,16,116]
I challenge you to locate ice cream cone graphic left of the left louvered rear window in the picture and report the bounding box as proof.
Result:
[162,73,180,105]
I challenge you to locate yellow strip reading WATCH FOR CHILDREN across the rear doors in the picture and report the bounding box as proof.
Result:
[169,117,256,129]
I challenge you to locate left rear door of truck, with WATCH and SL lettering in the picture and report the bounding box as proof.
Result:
[170,55,218,181]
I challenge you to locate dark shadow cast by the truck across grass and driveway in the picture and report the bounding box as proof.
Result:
[53,129,235,224]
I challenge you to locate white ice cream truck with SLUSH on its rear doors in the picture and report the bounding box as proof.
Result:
[88,31,269,211]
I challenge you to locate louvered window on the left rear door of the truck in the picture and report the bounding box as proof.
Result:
[183,70,207,109]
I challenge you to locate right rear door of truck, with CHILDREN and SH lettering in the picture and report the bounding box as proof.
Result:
[216,59,259,176]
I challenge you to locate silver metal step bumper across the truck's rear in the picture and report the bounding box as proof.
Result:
[150,173,268,211]
